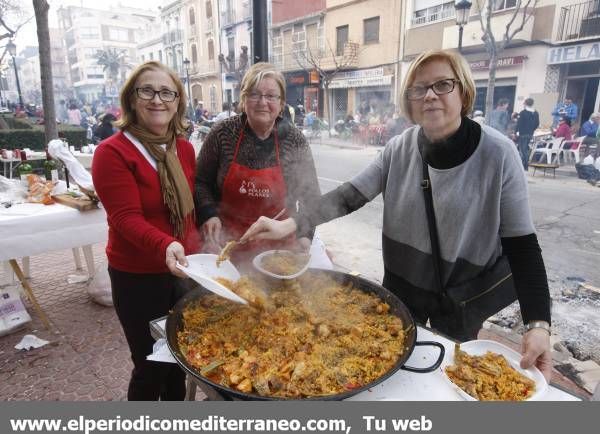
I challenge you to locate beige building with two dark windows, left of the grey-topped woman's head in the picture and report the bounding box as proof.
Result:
[324,0,405,122]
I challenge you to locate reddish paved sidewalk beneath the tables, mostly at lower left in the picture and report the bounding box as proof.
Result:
[0,241,590,401]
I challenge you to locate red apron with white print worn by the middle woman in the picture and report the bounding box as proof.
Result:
[219,121,295,265]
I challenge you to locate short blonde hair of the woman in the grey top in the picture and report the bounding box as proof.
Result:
[400,50,475,122]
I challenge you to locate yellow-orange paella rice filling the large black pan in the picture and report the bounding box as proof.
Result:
[177,273,406,398]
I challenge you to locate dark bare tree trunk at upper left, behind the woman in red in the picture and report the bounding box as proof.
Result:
[33,0,58,143]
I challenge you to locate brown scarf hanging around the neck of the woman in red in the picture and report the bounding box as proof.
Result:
[127,124,195,239]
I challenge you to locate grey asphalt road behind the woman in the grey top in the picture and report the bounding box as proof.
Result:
[312,145,600,287]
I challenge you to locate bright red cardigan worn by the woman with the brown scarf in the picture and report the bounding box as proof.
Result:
[92,132,199,273]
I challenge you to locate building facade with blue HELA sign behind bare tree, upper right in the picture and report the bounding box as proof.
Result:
[402,0,600,127]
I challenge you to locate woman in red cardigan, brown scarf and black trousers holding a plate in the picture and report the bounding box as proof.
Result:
[92,62,199,400]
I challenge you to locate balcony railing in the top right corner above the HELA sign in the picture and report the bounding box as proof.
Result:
[556,0,600,41]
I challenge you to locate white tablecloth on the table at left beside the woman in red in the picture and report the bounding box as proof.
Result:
[0,203,108,261]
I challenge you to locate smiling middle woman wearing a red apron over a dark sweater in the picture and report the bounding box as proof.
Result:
[196,62,320,267]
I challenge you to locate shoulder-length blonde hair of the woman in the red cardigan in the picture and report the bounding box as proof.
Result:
[115,60,189,136]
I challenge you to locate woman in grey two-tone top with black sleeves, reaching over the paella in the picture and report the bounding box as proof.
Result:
[241,50,552,379]
